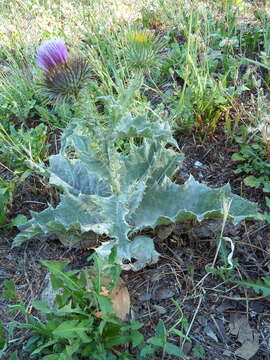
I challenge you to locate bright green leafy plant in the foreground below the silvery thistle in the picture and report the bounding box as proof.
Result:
[0,248,190,360]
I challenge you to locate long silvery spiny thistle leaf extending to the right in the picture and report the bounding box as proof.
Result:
[133,176,258,230]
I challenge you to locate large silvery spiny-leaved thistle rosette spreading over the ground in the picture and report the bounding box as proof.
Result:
[13,90,257,270]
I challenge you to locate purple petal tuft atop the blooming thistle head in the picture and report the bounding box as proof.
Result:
[36,38,69,71]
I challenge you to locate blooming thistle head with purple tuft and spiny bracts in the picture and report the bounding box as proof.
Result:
[36,38,90,102]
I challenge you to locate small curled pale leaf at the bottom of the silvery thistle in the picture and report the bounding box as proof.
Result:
[96,236,159,271]
